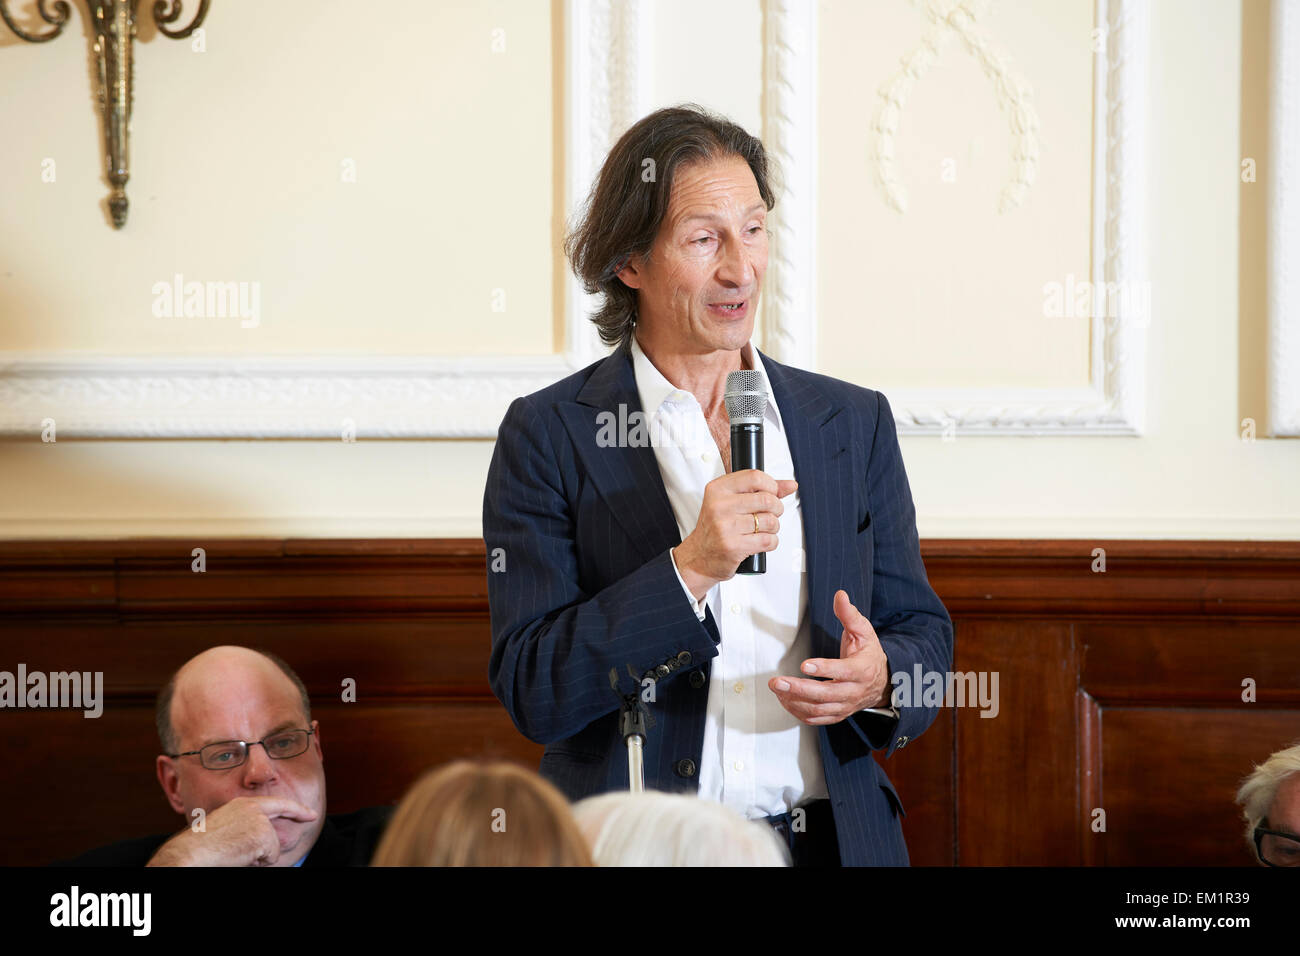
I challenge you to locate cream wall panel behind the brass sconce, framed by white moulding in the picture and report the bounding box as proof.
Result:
[0,0,558,355]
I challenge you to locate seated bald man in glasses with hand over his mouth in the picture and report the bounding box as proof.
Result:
[69,646,391,866]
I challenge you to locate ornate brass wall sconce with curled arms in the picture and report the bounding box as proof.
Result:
[0,0,209,229]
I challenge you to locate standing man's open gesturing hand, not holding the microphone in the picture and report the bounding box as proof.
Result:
[767,591,889,724]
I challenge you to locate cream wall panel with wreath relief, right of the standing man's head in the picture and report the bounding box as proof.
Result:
[818,0,1093,389]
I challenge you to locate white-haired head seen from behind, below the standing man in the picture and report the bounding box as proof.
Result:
[573,791,790,866]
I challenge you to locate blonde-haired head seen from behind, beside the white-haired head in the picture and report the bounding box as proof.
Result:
[371,761,592,866]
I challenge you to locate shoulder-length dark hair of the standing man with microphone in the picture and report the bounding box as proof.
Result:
[564,103,776,346]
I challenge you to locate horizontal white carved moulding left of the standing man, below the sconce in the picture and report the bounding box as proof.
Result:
[0,355,585,440]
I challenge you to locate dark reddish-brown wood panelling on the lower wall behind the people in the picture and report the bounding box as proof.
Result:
[0,540,1300,865]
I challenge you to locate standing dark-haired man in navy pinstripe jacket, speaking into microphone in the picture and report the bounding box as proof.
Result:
[484,107,953,866]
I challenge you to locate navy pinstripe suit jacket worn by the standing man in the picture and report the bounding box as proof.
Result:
[484,347,953,865]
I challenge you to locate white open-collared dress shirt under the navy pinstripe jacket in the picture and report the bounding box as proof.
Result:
[632,336,827,817]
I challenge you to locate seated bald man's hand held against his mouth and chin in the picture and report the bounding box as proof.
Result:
[146,797,317,866]
